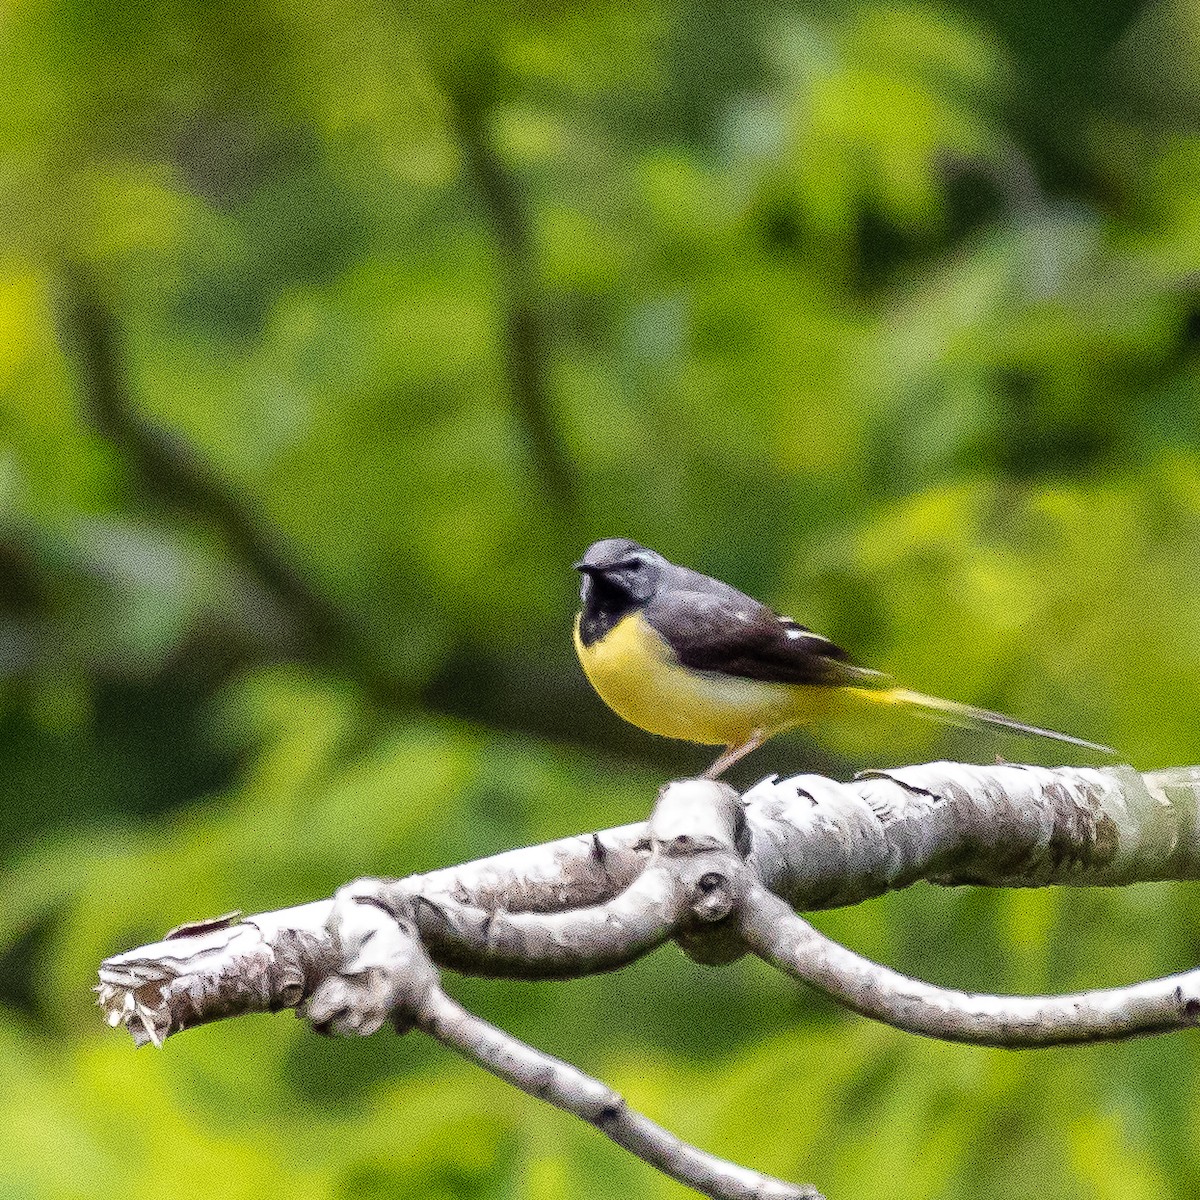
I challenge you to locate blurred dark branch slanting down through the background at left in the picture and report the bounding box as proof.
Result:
[59,270,402,704]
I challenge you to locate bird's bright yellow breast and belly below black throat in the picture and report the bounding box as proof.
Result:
[575,611,834,745]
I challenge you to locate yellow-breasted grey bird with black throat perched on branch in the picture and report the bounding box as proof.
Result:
[574,538,1115,779]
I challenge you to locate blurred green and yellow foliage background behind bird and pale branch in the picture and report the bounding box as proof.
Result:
[0,0,1200,1200]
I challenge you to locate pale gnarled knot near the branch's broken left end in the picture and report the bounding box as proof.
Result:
[302,880,438,1037]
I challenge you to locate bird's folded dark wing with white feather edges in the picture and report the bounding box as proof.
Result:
[644,588,886,688]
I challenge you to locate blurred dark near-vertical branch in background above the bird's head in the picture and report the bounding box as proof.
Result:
[448,64,576,512]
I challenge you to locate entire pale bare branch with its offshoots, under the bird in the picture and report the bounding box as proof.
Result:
[97,763,1200,1200]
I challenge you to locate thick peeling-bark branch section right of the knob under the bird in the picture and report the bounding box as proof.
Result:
[745,762,1200,911]
